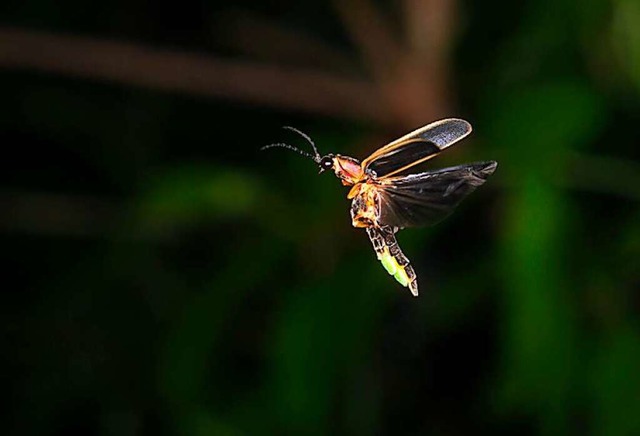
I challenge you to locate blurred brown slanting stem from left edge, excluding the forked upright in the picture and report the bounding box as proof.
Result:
[0,28,384,121]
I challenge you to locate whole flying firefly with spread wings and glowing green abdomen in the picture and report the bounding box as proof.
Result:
[262,118,498,296]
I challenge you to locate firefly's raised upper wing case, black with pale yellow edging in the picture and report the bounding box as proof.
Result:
[362,118,471,177]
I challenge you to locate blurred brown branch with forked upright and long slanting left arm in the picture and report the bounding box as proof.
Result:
[0,0,454,128]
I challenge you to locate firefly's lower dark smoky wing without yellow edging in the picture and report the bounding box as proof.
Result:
[376,161,498,228]
